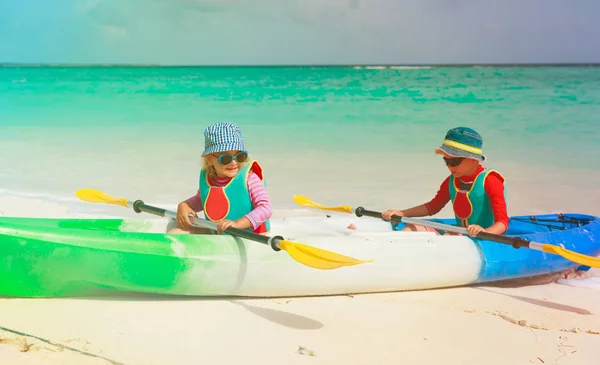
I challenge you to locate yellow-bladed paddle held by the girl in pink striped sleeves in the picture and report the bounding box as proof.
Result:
[75,189,372,270]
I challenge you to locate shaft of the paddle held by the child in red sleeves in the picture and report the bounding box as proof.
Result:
[354,207,543,251]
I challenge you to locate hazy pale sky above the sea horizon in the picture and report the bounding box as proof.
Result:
[0,0,600,65]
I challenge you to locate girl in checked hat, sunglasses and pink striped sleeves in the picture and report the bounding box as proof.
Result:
[169,122,272,234]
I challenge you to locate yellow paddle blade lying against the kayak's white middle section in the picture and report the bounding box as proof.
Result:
[279,240,373,270]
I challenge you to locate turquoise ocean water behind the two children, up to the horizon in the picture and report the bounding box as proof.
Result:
[0,67,600,219]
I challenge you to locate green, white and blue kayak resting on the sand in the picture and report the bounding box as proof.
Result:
[0,209,600,297]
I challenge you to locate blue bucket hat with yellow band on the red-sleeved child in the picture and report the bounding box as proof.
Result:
[435,127,485,162]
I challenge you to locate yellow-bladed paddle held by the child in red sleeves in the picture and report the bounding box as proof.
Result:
[294,195,600,267]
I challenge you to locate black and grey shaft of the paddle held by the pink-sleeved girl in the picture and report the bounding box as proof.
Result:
[127,200,283,251]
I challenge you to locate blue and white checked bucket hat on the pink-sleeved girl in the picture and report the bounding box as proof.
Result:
[202,122,246,156]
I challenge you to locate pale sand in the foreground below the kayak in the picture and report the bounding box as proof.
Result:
[0,279,600,365]
